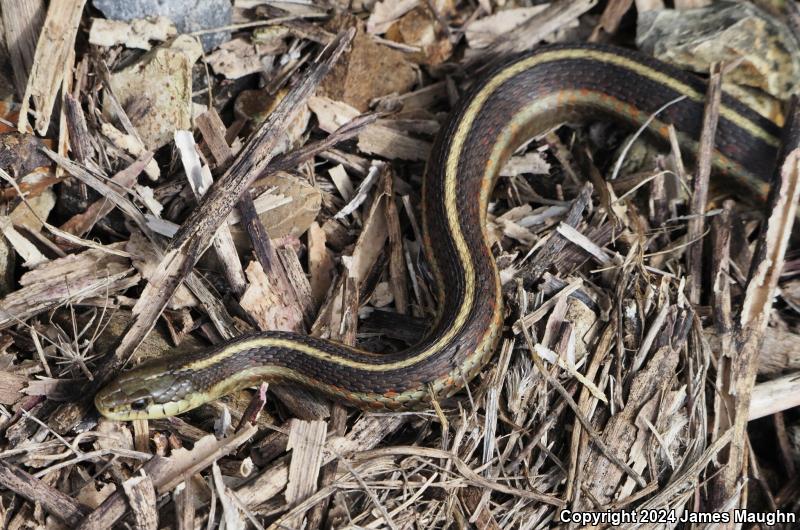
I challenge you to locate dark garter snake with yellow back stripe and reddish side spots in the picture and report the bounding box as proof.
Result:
[95,44,780,420]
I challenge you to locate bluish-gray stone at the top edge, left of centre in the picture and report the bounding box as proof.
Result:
[92,0,233,51]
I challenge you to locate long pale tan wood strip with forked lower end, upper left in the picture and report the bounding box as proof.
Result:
[17,0,86,136]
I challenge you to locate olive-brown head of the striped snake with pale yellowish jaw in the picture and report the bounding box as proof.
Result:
[94,362,207,421]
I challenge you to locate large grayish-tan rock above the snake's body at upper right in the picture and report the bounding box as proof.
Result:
[636,2,800,99]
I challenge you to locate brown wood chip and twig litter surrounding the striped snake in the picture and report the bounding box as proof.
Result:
[0,0,800,530]
